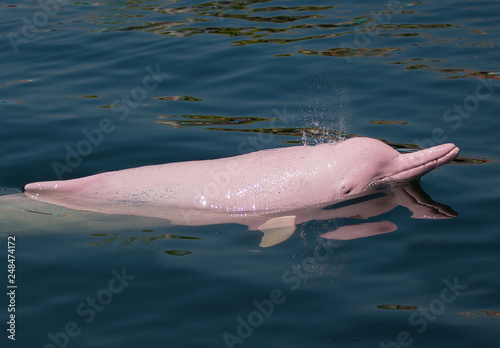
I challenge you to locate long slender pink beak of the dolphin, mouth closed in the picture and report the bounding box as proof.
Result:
[368,144,460,187]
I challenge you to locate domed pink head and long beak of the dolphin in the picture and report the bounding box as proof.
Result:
[333,137,459,198]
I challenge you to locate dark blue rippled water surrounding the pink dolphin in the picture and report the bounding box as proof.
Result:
[0,0,500,348]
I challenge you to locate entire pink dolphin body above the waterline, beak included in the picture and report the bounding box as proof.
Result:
[25,137,459,214]
